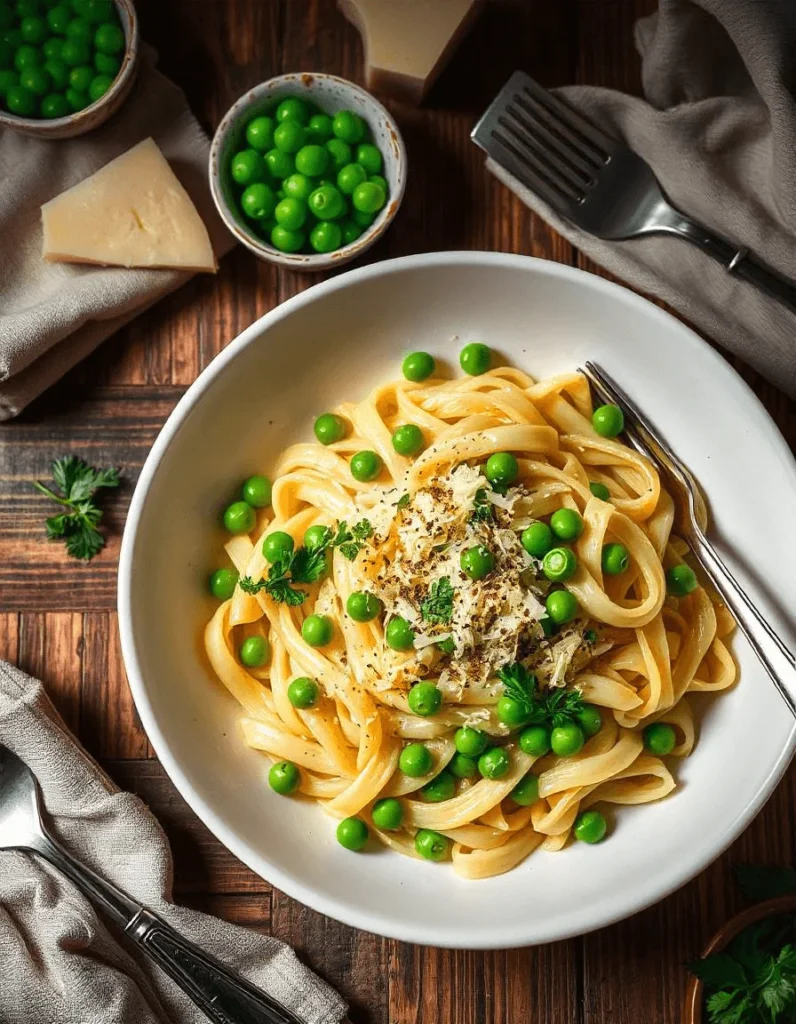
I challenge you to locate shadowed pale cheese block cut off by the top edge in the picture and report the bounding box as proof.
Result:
[337,0,481,103]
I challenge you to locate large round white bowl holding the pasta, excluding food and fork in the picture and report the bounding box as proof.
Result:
[119,253,796,947]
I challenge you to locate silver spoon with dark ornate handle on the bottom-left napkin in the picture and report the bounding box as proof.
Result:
[0,744,304,1024]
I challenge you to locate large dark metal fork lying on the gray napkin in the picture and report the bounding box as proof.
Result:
[471,72,796,309]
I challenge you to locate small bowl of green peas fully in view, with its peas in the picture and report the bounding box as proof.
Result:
[210,74,407,270]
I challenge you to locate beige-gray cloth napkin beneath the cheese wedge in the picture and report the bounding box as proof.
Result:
[0,46,234,420]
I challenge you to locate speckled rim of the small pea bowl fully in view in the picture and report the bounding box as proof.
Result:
[208,72,407,270]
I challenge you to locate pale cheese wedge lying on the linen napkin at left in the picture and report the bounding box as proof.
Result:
[41,138,216,273]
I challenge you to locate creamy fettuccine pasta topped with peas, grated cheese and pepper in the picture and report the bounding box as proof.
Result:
[205,356,736,879]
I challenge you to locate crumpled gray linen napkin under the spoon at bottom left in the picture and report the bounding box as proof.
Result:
[0,662,345,1024]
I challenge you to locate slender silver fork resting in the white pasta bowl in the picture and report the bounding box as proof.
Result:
[580,362,796,716]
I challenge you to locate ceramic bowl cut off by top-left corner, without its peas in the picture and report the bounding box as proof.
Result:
[0,0,138,138]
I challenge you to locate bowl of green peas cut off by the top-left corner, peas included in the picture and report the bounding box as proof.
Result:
[0,0,138,138]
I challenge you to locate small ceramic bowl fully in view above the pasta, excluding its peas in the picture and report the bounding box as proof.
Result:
[209,73,407,270]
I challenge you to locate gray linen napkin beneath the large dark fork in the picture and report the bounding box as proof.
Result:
[488,0,796,396]
